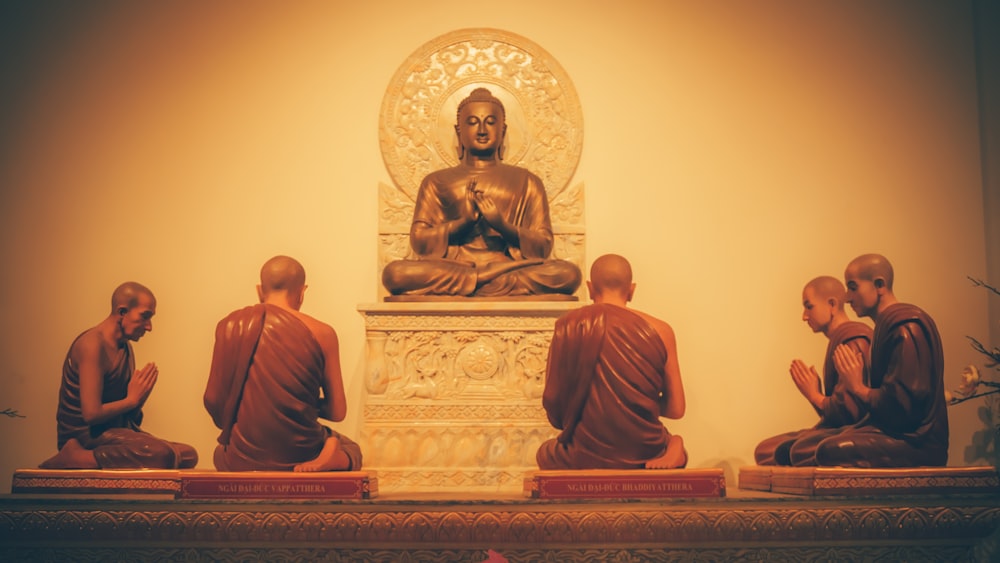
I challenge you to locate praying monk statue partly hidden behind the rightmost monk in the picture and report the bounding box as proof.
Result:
[754,276,872,466]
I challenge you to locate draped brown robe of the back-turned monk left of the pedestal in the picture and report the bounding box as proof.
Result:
[205,304,361,471]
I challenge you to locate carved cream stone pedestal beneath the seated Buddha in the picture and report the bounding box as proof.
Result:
[358,300,580,492]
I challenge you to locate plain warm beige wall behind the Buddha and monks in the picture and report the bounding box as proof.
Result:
[0,0,1000,491]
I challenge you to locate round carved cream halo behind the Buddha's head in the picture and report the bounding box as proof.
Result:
[379,28,583,202]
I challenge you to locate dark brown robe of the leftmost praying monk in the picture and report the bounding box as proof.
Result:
[56,335,198,469]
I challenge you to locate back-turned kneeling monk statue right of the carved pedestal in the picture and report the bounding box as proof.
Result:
[536,254,687,469]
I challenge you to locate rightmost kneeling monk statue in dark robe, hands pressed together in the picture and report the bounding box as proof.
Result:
[816,254,948,468]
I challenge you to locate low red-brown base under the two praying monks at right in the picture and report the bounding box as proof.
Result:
[739,465,1000,496]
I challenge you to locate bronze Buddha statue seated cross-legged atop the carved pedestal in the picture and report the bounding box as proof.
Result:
[382,88,581,297]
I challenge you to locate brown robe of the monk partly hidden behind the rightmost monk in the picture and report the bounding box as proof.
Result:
[754,321,872,465]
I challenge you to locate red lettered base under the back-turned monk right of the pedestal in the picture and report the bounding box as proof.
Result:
[524,468,726,499]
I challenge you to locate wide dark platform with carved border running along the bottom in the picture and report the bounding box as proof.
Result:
[0,488,1000,563]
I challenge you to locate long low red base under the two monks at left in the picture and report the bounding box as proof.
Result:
[11,469,378,500]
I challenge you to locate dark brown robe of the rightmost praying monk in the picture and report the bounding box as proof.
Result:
[816,303,948,467]
